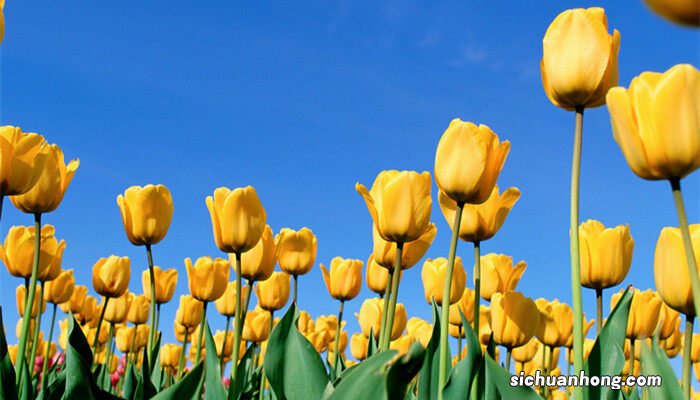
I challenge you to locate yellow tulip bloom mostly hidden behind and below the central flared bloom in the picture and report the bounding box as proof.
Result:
[372,223,437,271]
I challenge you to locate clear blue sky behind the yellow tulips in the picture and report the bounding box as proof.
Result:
[0,1,700,370]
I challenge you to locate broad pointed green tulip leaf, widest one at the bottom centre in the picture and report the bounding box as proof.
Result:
[263,304,329,400]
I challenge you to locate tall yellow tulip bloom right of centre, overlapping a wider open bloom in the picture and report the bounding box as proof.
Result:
[435,118,510,204]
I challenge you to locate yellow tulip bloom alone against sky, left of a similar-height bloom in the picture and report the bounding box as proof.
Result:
[117,184,173,246]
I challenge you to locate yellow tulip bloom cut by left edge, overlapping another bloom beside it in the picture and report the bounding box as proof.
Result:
[0,126,48,196]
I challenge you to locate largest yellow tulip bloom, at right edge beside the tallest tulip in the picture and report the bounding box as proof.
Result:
[607,64,700,180]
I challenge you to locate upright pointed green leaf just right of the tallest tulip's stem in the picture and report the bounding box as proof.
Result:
[583,289,633,399]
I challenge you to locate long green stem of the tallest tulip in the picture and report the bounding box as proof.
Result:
[569,106,583,399]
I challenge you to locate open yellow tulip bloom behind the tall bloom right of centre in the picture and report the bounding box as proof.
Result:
[438,185,520,242]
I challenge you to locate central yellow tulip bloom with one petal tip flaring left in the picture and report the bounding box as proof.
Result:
[355,170,433,243]
